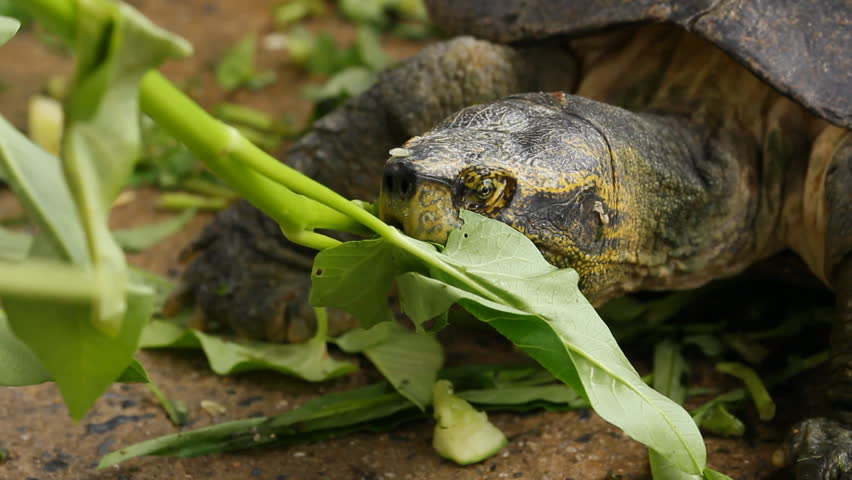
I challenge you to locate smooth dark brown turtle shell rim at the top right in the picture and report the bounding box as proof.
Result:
[426,0,852,128]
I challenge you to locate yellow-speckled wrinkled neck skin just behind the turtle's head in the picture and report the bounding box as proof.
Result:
[548,96,773,304]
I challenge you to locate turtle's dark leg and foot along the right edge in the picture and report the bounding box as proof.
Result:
[785,132,852,480]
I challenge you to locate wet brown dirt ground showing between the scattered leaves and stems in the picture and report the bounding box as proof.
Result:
[0,0,824,480]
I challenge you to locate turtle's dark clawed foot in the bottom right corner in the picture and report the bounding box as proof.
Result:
[784,418,852,480]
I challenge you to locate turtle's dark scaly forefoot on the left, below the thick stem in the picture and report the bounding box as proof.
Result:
[173,202,354,343]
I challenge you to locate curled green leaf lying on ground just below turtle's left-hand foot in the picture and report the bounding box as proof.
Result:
[140,320,356,382]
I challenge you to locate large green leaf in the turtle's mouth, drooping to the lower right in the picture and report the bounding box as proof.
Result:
[311,212,706,474]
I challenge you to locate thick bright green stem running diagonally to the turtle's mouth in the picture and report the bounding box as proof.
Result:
[28,0,504,302]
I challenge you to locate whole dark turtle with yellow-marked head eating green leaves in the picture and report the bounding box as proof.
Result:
[175,0,852,479]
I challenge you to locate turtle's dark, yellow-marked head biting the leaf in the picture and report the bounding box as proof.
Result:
[379,94,619,290]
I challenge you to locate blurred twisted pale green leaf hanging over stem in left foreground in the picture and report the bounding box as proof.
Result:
[62,2,190,334]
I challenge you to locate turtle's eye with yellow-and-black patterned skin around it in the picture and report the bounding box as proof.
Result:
[453,166,516,214]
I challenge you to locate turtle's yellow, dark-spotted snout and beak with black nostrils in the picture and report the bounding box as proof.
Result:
[379,159,462,244]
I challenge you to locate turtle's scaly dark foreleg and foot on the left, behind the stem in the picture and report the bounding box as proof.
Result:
[174,37,575,342]
